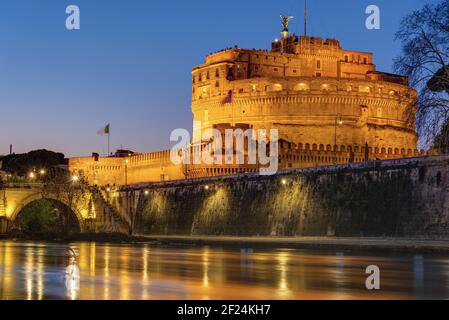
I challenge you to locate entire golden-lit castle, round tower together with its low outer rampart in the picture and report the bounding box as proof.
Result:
[69,21,419,186]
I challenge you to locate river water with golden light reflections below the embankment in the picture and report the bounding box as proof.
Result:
[0,241,449,300]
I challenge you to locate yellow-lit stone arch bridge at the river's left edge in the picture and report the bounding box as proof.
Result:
[0,183,133,234]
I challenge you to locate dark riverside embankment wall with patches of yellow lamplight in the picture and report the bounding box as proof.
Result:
[134,157,449,237]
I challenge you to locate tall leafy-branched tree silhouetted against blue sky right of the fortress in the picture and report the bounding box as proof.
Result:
[395,0,449,147]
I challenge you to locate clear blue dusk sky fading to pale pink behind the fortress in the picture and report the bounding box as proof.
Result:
[0,0,433,156]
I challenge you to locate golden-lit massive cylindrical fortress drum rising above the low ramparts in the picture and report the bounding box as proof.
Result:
[192,36,417,159]
